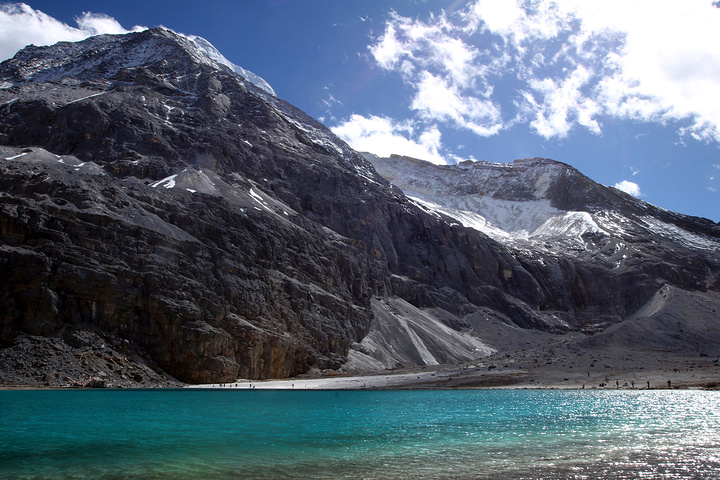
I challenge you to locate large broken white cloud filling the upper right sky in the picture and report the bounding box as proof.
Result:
[344,0,720,151]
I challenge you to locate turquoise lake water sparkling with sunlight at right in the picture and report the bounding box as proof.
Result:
[0,389,720,480]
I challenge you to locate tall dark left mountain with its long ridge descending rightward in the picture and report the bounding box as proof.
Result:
[0,29,720,385]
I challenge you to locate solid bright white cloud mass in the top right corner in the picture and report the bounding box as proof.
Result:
[558,0,720,141]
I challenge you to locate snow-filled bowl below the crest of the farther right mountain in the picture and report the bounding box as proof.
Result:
[371,156,580,241]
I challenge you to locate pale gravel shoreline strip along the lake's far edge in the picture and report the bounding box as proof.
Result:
[0,348,720,390]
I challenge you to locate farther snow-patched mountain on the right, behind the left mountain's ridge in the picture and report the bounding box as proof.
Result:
[366,154,720,324]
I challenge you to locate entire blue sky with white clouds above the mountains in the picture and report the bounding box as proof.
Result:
[0,0,720,222]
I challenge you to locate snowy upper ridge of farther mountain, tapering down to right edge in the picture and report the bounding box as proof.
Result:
[366,154,718,244]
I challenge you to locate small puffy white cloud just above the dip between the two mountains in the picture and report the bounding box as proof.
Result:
[332,115,446,164]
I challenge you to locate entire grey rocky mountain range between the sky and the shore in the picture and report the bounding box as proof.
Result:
[0,29,720,386]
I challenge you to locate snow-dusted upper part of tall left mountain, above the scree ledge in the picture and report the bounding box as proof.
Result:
[0,28,383,183]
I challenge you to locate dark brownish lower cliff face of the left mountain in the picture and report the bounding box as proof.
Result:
[2,144,382,382]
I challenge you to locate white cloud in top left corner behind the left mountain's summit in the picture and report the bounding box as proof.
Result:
[0,3,145,60]
